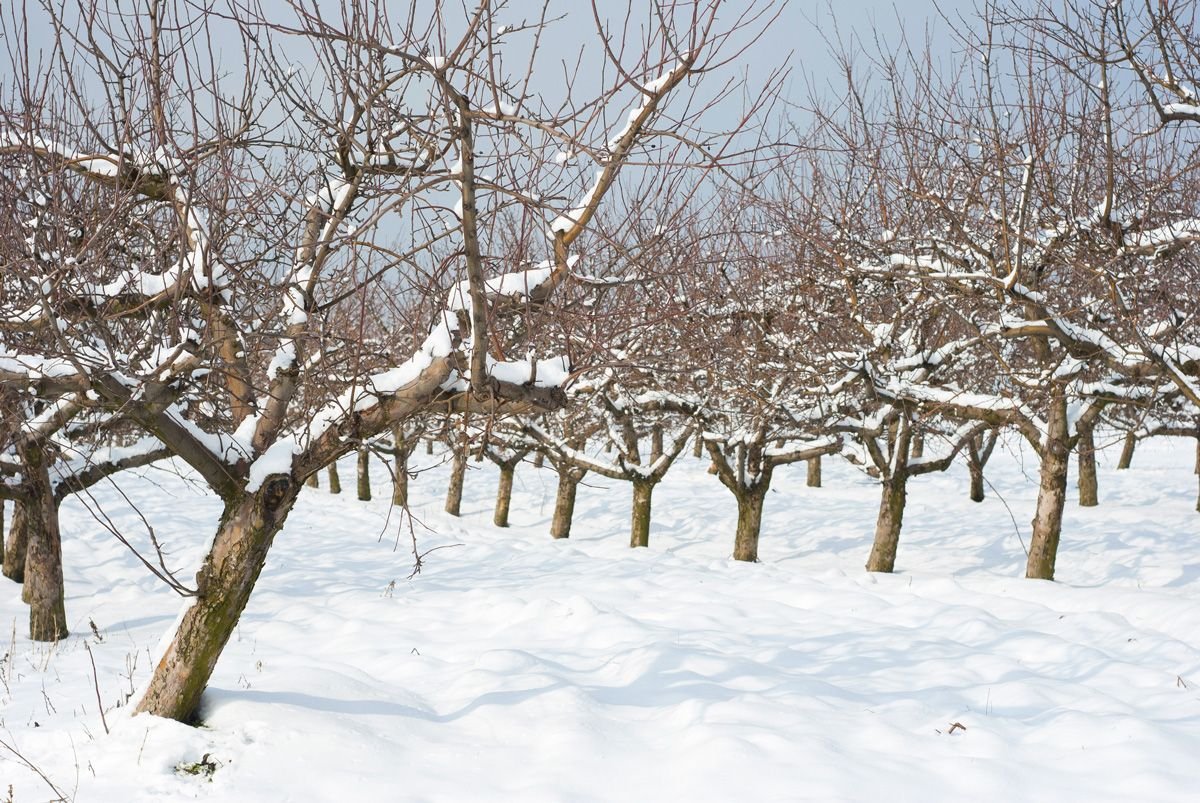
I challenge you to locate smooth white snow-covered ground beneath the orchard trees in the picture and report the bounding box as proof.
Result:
[0,439,1200,803]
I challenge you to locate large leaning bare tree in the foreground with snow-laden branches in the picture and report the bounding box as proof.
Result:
[0,0,766,719]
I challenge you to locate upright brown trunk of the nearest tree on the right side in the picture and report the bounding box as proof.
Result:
[1025,385,1070,580]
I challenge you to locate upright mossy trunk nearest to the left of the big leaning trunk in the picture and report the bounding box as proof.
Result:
[22,445,67,641]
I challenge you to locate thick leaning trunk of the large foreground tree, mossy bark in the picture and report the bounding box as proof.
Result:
[137,477,299,721]
